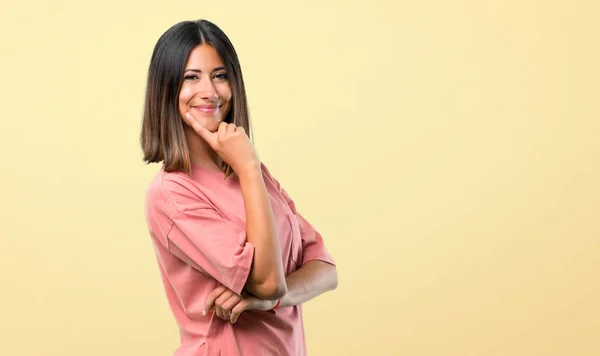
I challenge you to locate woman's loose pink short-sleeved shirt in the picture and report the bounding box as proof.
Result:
[145,165,334,356]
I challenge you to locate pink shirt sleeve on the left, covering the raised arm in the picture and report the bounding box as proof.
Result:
[157,174,254,294]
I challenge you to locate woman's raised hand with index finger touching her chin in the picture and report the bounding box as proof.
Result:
[185,112,260,175]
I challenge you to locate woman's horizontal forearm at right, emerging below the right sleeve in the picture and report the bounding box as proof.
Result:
[279,261,338,307]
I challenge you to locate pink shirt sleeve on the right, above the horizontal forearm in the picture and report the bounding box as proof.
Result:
[263,166,335,266]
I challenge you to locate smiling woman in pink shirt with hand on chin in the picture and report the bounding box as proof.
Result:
[141,20,337,356]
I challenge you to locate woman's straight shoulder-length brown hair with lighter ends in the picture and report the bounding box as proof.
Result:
[140,20,251,177]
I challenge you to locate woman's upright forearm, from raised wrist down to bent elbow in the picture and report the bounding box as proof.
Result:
[238,165,287,300]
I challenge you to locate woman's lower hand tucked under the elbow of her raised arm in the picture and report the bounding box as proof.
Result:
[203,285,277,324]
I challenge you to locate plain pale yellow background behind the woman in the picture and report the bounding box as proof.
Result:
[0,0,600,356]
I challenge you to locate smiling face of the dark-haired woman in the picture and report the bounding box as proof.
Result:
[179,44,231,132]
